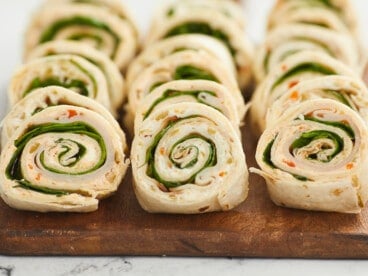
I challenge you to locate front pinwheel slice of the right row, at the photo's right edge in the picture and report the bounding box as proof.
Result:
[251,99,368,213]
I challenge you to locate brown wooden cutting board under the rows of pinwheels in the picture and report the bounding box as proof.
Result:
[0,112,368,258]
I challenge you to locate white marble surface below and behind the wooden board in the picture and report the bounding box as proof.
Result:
[0,0,368,276]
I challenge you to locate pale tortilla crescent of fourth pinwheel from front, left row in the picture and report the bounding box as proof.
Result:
[27,40,126,110]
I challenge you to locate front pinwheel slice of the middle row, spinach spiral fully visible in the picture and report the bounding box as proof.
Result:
[131,103,248,214]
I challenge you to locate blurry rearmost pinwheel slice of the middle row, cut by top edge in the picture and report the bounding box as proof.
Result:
[152,0,245,29]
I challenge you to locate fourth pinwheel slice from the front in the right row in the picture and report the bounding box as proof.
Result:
[254,23,361,81]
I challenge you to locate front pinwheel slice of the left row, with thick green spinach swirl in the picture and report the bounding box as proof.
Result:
[0,105,128,212]
